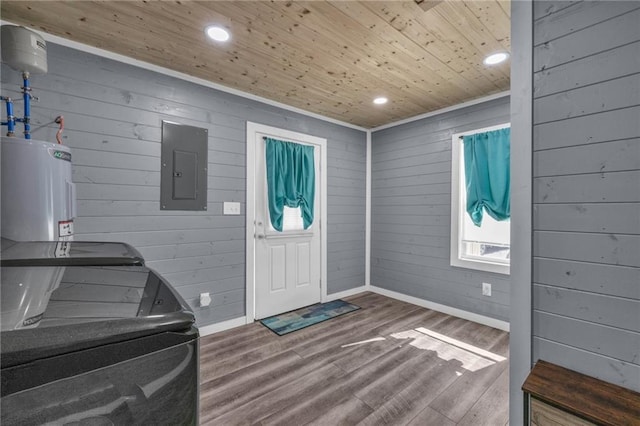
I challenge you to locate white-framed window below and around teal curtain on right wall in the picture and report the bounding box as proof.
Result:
[451,123,511,274]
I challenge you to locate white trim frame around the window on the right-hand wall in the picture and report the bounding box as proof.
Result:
[450,122,511,275]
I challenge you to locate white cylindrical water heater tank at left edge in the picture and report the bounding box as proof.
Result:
[1,136,76,241]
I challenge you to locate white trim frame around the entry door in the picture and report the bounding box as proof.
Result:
[245,121,327,324]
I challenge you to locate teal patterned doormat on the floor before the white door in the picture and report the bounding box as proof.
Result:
[260,299,360,336]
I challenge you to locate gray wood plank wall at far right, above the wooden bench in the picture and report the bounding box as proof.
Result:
[533,1,640,391]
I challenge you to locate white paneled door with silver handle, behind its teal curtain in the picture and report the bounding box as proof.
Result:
[248,123,324,319]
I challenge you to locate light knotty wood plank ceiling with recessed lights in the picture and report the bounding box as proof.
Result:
[1,0,510,128]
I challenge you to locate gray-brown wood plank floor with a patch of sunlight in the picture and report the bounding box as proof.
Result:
[200,293,509,426]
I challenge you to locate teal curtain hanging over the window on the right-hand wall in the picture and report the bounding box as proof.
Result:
[463,129,511,226]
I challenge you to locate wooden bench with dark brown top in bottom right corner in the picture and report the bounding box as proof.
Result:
[522,360,640,426]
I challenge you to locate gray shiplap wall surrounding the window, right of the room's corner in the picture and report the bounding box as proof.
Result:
[371,97,515,321]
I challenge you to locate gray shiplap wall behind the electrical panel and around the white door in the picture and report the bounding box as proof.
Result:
[2,43,366,326]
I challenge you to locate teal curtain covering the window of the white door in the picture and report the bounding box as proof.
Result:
[264,138,316,232]
